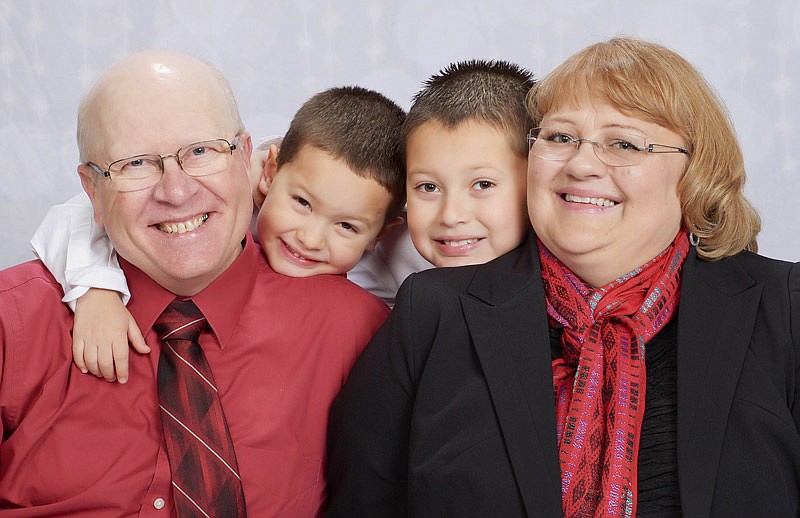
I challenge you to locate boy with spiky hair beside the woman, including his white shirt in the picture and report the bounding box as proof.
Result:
[349,60,533,292]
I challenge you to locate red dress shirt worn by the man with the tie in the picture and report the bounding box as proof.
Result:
[0,236,389,518]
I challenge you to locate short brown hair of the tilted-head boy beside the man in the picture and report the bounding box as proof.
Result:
[277,86,406,220]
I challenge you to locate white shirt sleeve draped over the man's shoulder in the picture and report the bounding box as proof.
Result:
[31,192,131,311]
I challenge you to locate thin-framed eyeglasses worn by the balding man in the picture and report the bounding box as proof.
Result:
[86,135,239,192]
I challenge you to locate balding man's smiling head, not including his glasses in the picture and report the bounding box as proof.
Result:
[78,51,253,296]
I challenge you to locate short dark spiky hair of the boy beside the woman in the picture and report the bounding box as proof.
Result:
[403,60,533,157]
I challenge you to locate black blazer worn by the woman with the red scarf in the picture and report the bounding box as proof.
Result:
[328,239,800,518]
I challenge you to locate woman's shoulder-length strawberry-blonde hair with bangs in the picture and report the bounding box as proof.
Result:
[528,38,761,260]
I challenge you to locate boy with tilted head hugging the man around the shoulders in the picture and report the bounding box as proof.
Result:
[32,87,405,383]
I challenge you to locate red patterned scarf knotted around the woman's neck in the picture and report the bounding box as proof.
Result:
[539,230,689,518]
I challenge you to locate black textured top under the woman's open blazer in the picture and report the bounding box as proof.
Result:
[550,317,683,518]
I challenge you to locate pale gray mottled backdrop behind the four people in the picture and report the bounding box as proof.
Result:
[0,0,800,267]
